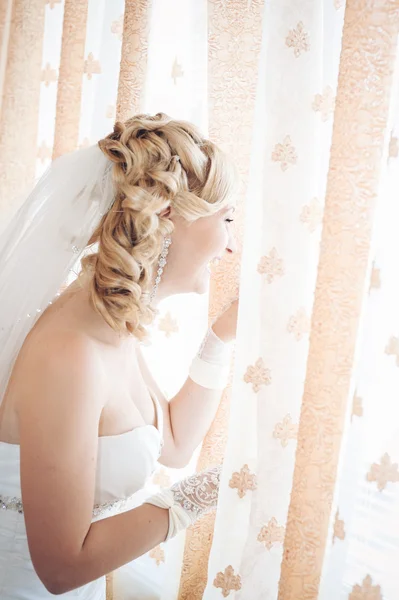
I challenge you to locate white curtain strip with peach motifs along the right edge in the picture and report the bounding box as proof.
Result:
[319,4,399,600]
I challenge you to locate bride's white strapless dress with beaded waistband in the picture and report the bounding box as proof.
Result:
[0,398,163,600]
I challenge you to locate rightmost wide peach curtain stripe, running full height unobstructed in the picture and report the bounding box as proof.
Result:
[279,0,399,600]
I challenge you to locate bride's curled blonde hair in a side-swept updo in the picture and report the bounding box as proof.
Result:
[82,113,237,340]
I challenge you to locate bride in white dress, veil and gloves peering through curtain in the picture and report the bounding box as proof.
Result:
[0,113,238,600]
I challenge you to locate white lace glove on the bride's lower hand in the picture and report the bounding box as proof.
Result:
[146,465,222,542]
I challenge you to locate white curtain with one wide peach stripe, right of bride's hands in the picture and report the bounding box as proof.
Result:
[203,0,399,600]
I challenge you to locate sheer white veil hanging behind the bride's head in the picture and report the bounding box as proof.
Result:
[0,145,114,402]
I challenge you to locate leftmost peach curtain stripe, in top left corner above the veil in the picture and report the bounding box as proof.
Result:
[0,0,44,229]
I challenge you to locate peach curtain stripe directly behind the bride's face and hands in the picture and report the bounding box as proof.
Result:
[178,0,263,600]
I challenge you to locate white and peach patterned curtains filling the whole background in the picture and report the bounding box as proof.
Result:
[0,0,399,600]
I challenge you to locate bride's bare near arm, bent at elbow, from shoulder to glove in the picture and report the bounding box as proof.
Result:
[17,334,169,594]
